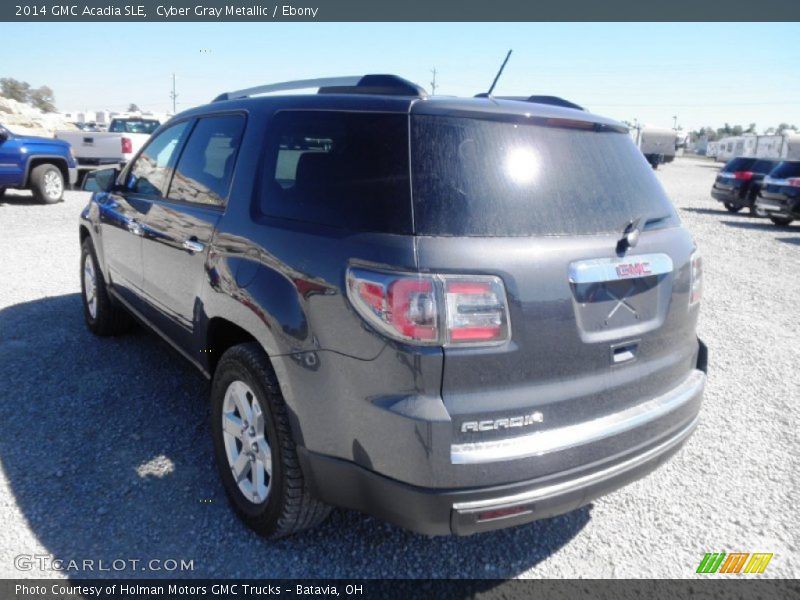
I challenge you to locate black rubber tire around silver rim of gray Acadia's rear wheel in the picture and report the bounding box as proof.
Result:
[211,343,331,539]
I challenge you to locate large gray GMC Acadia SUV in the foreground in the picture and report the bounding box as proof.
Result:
[79,75,706,537]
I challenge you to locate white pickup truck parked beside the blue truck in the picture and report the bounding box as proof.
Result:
[55,117,161,185]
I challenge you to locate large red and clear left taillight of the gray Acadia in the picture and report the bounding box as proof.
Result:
[347,268,510,346]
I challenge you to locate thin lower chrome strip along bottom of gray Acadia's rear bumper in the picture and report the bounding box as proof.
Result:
[453,415,700,512]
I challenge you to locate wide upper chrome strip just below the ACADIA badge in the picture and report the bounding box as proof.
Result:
[450,370,706,465]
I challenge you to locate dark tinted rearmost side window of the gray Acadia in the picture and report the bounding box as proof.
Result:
[261,111,412,233]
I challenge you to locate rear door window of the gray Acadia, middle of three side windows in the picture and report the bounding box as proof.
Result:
[169,115,245,206]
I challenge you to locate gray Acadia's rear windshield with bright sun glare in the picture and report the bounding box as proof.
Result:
[411,115,678,236]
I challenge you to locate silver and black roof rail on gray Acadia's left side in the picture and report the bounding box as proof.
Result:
[213,75,427,102]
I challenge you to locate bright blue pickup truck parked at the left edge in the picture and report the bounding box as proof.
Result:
[0,125,78,204]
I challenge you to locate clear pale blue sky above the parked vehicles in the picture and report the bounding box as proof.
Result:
[0,22,800,131]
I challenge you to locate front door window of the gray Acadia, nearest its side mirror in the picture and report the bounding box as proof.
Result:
[125,121,188,197]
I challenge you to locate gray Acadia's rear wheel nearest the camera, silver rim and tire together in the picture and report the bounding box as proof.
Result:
[211,343,330,538]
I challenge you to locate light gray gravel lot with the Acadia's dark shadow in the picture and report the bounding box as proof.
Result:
[0,159,800,578]
